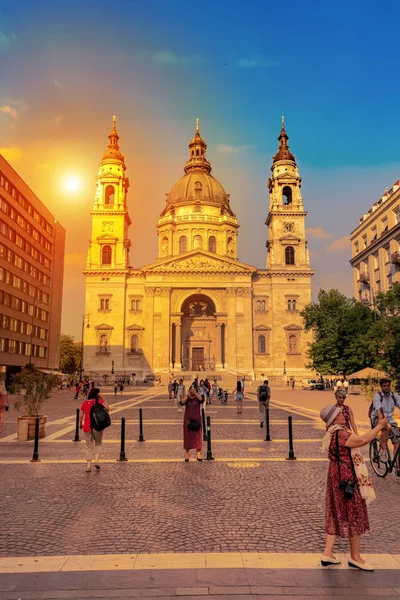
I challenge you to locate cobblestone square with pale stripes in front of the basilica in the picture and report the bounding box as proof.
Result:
[0,388,400,556]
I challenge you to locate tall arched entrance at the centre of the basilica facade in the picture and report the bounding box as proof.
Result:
[181,294,217,371]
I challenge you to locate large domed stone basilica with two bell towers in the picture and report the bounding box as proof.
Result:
[83,117,313,380]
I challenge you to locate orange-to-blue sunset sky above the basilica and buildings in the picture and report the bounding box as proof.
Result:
[0,0,400,336]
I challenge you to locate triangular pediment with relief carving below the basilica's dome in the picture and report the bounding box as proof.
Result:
[142,250,257,275]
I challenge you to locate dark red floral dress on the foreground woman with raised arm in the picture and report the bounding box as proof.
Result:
[325,429,370,538]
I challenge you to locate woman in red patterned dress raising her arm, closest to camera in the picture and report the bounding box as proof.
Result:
[320,404,388,571]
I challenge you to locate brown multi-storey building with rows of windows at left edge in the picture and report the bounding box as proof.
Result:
[0,155,65,381]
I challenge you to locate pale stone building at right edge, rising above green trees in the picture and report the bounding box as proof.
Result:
[350,180,400,306]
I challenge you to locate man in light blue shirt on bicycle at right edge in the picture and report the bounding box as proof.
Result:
[369,377,400,460]
